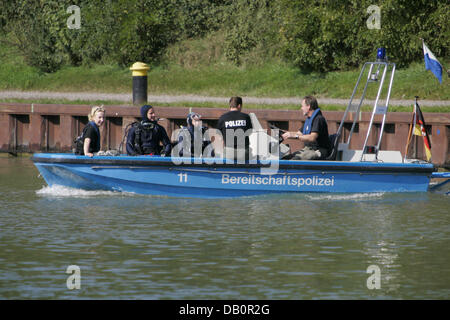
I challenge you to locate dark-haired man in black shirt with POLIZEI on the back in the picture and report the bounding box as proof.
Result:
[217,97,253,160]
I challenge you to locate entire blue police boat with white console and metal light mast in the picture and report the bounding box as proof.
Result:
[32,52,448,198]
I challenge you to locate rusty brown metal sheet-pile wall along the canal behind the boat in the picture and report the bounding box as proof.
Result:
[0,103,450,166]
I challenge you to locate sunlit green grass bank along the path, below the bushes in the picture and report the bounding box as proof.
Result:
[0,36,450,112]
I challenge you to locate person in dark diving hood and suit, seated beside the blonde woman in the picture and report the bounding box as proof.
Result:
[126,105,172,156]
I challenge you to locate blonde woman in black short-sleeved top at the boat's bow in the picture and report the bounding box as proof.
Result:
[83,106,105,157]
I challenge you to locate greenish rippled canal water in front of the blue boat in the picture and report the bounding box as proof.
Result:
[0,158,450,300]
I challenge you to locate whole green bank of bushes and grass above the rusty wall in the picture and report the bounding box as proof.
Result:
[0,0,450,112]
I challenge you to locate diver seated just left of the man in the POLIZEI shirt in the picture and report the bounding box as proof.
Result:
[174,112,214,157]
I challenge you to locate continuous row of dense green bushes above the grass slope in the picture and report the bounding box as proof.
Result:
[0,0,450,72]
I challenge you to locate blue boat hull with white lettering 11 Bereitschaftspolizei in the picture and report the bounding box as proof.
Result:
[32,153,434,198]
